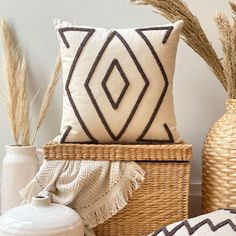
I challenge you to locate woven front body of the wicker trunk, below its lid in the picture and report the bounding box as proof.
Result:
[95,162,190,236]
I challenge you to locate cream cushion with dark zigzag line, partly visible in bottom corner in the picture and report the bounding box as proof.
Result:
[149,210,236,236]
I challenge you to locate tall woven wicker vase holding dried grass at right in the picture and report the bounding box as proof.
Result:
[202,99,236,213]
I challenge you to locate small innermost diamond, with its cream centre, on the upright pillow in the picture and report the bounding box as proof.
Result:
[102,59,129,110]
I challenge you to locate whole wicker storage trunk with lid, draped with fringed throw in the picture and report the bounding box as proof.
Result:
[44,144,192,236]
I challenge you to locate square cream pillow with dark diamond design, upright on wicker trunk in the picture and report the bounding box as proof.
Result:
[55,20,183,143]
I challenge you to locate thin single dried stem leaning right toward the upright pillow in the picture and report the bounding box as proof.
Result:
[32,54,61,144]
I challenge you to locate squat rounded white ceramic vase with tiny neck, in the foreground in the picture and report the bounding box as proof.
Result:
[0,195,84,236]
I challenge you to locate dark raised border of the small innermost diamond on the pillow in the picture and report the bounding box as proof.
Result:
[102,59,129,110]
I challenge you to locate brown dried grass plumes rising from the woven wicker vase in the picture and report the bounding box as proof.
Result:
[131,0,236,99]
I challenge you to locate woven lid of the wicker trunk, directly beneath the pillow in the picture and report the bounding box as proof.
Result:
[44,143,192,161]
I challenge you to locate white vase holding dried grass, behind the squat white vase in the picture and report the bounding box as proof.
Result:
[1,145,39,213]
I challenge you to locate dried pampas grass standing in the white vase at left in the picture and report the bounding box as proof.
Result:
[0,20,61,146]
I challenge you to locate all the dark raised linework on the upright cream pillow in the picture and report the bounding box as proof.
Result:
[59,26,173,143]
